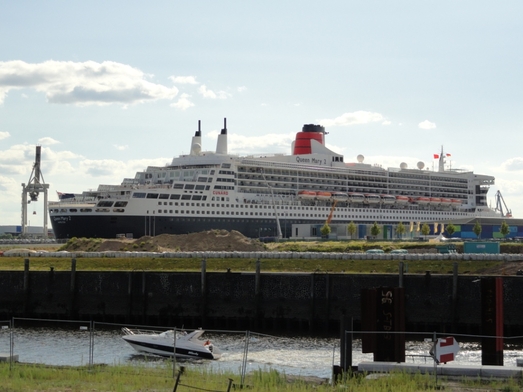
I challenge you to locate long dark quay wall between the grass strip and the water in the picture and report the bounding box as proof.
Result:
[0,268,523,336]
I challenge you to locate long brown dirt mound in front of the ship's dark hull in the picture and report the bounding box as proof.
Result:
[67,230,265,252]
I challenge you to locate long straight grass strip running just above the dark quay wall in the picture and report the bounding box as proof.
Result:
[0,255,503,274]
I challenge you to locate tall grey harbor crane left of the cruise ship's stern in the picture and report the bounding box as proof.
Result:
[22,146,49,237]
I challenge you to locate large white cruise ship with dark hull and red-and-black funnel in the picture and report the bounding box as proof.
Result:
[49,121,508,239]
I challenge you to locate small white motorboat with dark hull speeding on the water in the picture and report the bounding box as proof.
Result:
[122,327,221,359]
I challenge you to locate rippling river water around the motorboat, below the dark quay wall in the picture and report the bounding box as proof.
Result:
[0,327,523,378]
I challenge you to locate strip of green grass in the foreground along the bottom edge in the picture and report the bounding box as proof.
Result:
[0,363,521,392]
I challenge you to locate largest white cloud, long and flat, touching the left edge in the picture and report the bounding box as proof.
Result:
[0,60,178,106]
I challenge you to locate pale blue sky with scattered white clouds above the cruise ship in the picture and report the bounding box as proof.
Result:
[0,0,523,225]
